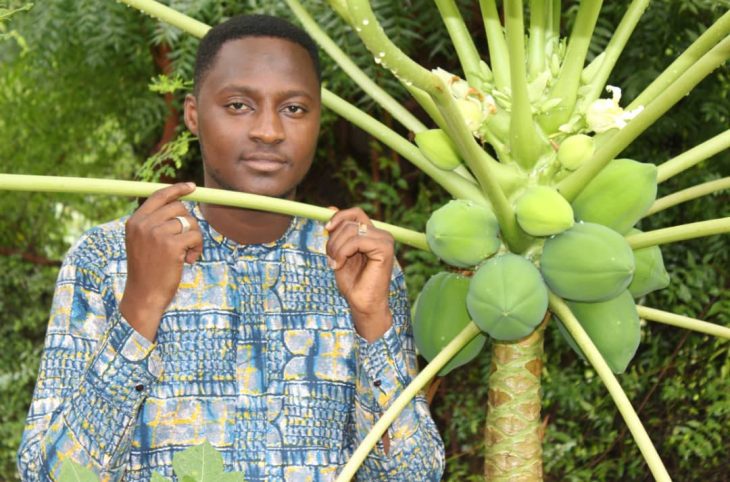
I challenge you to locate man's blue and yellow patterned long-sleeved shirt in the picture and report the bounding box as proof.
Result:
[18,203,444,482]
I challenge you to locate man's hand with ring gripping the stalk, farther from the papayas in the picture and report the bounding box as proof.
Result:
[119,183,203,341]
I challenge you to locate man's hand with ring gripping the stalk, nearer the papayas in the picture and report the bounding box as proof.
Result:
[325,208,394,343]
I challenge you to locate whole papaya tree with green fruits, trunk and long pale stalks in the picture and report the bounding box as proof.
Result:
[0,0,730,481]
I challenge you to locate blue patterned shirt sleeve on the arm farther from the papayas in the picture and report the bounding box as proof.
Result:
[18,228,162,481]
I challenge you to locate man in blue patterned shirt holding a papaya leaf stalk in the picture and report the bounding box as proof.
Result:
[18,16,443,481]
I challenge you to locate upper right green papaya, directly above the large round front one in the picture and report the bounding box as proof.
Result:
[573,159,657,234]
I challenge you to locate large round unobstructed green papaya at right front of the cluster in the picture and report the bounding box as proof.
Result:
[540,223,635,301]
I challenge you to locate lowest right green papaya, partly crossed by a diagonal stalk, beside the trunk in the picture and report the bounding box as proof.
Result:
[558,290,641,374]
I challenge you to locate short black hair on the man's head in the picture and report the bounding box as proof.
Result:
[194,14,322,94]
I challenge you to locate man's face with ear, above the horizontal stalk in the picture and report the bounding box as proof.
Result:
[185,37,320,199]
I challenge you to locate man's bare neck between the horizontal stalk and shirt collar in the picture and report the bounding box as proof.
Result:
[200,204,291,244]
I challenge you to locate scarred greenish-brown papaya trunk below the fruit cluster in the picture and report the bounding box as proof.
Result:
[484,316,547,482]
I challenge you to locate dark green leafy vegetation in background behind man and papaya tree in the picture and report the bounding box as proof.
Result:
[0,0,730,482]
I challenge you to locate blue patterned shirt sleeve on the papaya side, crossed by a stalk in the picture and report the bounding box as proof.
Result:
[352,266,445,481]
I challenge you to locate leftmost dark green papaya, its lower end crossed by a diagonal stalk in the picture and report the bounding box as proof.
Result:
[413,272,487,376]
